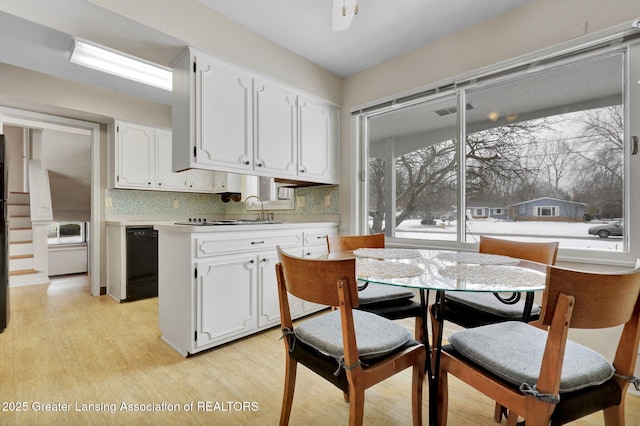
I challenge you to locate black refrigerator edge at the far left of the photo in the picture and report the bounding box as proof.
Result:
[0,135,9,333]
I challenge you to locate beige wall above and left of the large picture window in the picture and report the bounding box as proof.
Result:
[340,0,640,232]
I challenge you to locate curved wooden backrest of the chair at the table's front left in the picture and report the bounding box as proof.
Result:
[276,247,358,307]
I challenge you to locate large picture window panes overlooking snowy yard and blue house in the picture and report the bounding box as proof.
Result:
[364,49,628,251]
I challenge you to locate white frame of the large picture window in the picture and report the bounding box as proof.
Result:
[352,35,640,265]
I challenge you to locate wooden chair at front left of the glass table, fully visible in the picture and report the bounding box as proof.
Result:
[276,247,426,425]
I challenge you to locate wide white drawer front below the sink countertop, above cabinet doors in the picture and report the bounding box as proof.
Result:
[195,232,302,257]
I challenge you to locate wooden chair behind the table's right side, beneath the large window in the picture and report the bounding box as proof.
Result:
[444,236,559,328]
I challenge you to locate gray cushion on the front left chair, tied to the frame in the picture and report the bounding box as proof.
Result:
[294,310,412,360]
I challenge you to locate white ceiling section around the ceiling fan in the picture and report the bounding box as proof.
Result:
[198,0,528,77]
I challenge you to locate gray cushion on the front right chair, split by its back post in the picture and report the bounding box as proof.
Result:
[448,321,614,393]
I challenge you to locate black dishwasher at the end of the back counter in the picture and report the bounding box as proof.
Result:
[123,226,158,302]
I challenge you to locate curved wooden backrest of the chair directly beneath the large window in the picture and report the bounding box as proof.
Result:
[479,235,559,265]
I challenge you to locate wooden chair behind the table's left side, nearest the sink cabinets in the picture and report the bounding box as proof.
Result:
[327,234,424,341]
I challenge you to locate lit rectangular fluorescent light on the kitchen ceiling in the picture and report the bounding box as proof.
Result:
[69,39,172,91]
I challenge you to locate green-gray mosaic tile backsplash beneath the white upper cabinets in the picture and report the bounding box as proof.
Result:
[105,185,340,218]
